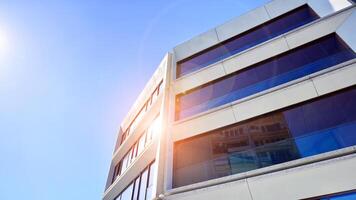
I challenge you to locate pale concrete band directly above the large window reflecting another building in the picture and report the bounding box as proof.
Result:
[172,59,356,142]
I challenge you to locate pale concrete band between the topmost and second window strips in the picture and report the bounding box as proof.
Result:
[174,7,356,94]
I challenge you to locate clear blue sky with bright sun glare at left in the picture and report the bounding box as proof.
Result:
[0,0,268,200]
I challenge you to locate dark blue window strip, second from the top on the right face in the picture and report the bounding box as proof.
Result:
[175,34,356,120]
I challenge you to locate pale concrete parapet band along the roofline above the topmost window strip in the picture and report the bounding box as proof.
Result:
[173,0,352,61]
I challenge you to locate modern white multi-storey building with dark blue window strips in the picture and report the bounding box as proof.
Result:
[103,0,356,200]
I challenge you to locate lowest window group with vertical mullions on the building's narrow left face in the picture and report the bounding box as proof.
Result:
[115,162,157,200]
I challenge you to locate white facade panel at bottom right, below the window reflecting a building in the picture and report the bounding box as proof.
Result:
[247,154,356,200]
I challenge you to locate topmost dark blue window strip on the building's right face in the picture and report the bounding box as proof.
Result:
[177,5,319,77]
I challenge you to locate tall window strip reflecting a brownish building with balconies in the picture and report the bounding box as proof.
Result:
[173,87,356,187]
